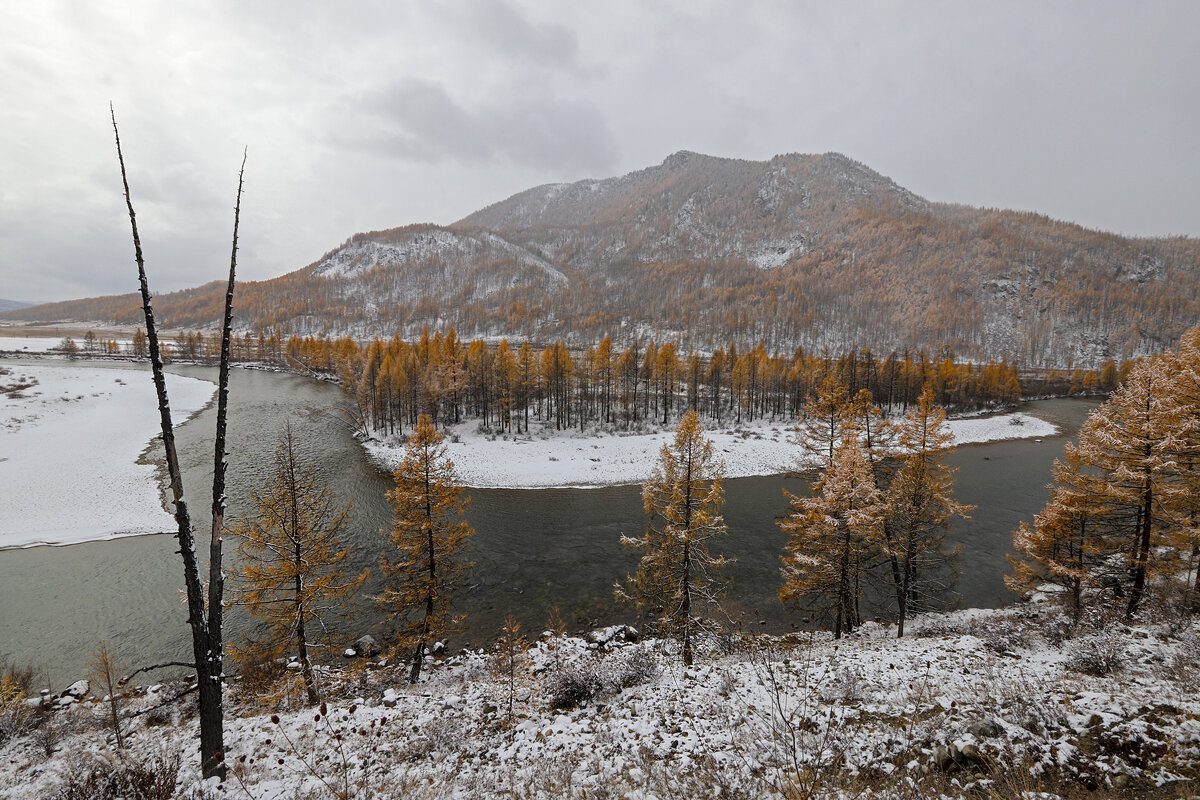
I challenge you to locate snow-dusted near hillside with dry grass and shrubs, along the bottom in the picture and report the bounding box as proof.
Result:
[0,603,1200,800]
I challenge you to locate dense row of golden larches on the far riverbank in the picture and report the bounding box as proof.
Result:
[336,329,1021,434]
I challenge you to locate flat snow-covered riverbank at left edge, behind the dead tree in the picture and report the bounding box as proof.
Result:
[0,362,216,547]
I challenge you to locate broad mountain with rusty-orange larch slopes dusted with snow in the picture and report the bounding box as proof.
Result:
[0,151,1200,366]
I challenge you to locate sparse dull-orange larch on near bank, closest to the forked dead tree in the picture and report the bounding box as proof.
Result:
[229,422,367,704]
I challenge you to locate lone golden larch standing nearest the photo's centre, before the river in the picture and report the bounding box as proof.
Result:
[617,410,727,666]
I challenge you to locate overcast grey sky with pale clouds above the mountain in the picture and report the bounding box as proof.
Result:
[0,0,1200,301]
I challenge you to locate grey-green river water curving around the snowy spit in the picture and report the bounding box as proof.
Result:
[0,365,1094,687]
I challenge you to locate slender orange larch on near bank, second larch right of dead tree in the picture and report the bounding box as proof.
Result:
[377,414,475,684]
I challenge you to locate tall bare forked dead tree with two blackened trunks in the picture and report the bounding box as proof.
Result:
[109,107,246,778]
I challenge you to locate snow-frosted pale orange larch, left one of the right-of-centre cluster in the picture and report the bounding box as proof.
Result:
[778,434,884,638]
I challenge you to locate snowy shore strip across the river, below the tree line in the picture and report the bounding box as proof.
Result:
[365,413,1057,489]
